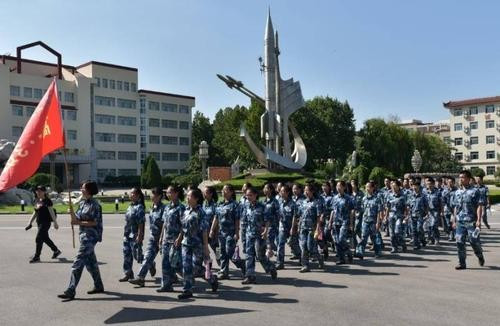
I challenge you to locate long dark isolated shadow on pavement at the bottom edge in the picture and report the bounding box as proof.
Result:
[104,305,253,324]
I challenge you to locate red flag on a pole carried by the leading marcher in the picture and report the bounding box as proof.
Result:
[0,79,64,192]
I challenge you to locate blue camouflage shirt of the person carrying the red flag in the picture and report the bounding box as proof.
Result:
[75,198,103,242]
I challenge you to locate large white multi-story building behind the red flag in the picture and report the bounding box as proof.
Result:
[0,42,195,184]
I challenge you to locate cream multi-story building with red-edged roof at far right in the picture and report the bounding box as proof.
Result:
[443,96,500,178]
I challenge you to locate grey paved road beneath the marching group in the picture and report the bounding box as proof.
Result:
[0,210,500,326]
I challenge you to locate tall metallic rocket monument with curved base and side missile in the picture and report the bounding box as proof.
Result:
[217,12,307,170]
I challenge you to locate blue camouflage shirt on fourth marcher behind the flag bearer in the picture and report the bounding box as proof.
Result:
[181,205,209,247]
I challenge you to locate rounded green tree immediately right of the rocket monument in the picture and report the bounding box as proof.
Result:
[291,96,355,171]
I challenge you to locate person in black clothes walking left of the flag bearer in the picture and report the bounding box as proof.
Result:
[25,186,61,263]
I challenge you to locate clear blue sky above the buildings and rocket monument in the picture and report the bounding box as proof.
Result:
[0,0,500,128]
